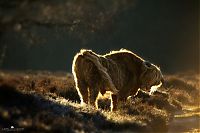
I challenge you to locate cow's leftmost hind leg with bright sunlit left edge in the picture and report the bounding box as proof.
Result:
[77,82,88,105]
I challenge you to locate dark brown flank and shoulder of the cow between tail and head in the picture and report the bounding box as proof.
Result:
[104,51,143,96]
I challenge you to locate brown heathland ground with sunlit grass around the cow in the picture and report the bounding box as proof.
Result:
[0,71,200,133]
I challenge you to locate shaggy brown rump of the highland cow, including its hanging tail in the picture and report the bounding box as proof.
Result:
[72,50,118,94]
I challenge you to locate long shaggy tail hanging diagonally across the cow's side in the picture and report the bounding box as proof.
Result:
[81,50,118,94]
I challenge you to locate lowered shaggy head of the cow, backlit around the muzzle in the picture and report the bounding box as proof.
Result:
[140,61,164,92]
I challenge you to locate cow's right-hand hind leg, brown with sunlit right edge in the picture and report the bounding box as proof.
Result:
[89,88,99,109]
